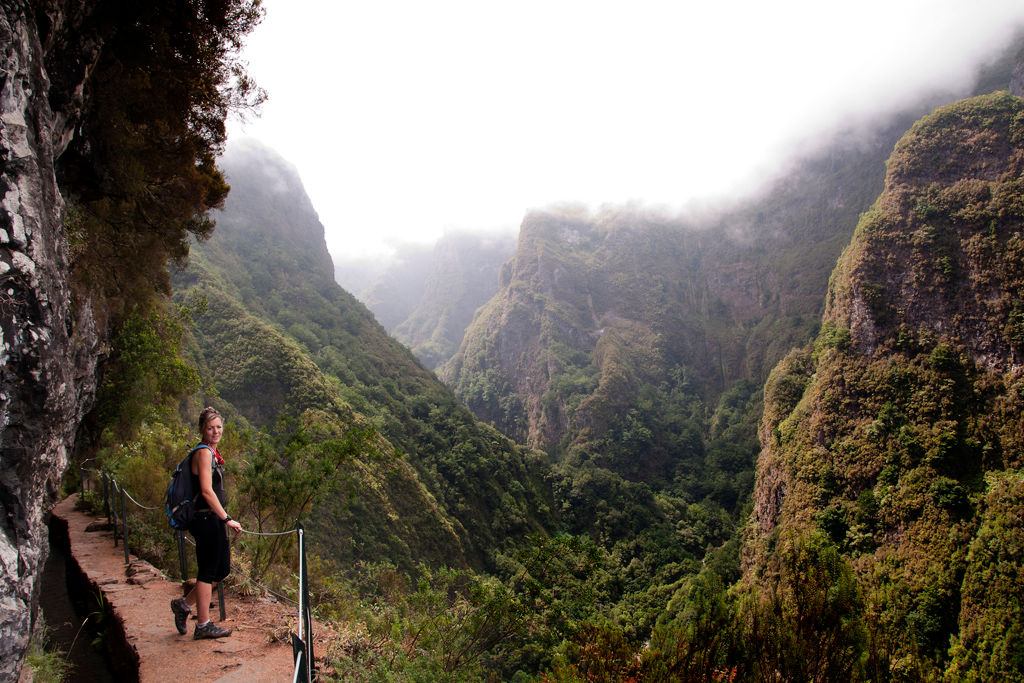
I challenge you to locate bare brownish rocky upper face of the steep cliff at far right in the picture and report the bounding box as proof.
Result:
[825,93,1024,367]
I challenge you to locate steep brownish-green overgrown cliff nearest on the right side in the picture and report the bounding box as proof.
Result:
[744,93,1024,680]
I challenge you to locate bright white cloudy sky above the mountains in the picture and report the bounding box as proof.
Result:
[231,0,1024,261]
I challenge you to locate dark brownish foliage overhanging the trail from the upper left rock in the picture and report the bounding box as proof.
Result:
[56,0,262,326]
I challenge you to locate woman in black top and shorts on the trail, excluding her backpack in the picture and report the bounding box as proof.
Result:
[171,408,242,640]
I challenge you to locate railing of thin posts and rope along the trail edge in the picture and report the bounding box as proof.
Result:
[79,458,315,683]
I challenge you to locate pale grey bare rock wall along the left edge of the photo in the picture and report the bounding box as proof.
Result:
[0,0,99,680]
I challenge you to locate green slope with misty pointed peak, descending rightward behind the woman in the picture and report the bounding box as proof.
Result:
[175,141,550,567]
